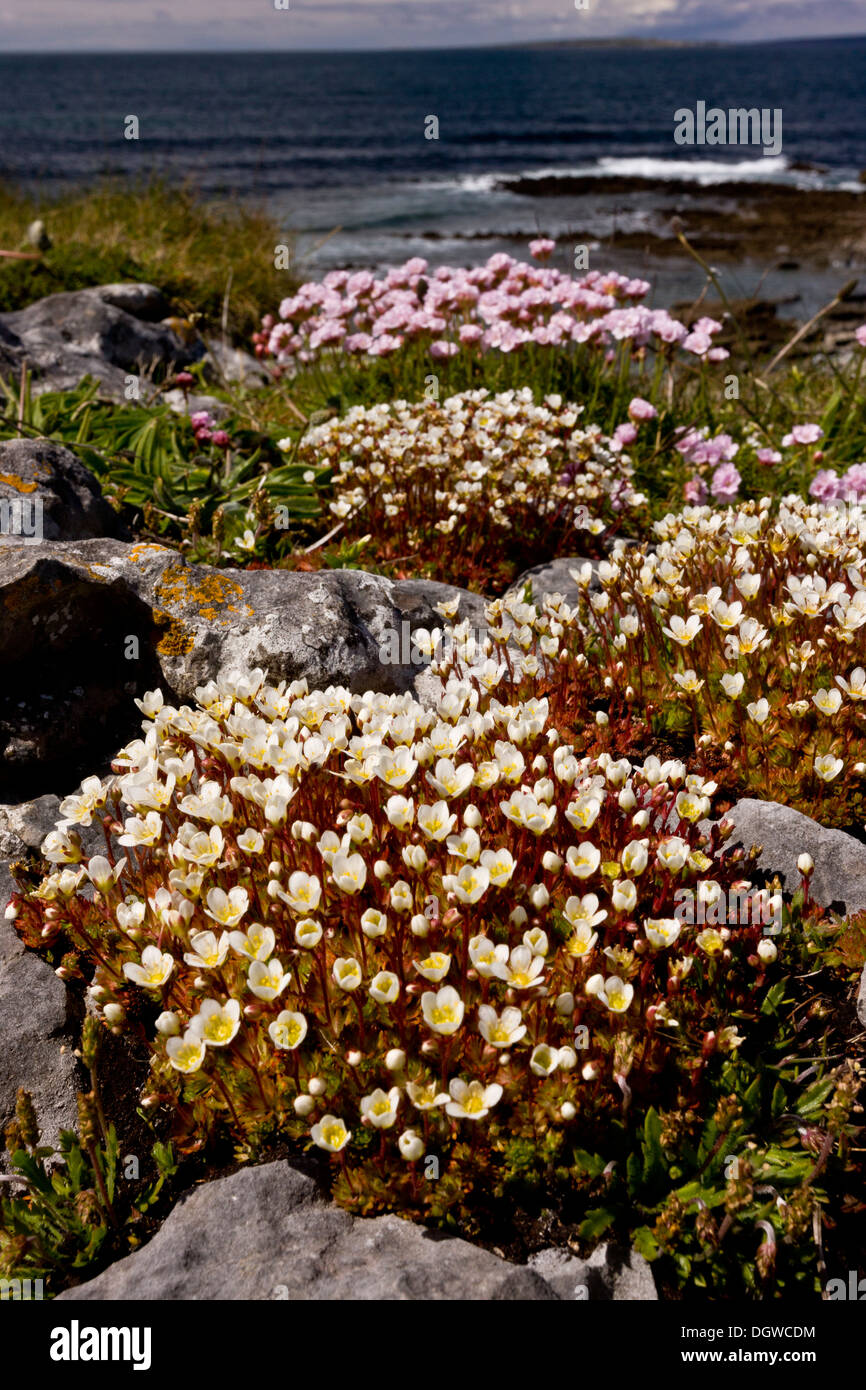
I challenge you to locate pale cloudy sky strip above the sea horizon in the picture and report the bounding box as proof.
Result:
[0,0,866,53]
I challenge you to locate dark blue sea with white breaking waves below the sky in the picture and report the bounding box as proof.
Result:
[0,38,866,311]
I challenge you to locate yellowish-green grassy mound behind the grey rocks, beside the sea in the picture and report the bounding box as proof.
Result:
[0,179,292,338]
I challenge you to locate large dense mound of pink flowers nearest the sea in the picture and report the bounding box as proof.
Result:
[254,239,728,366]
